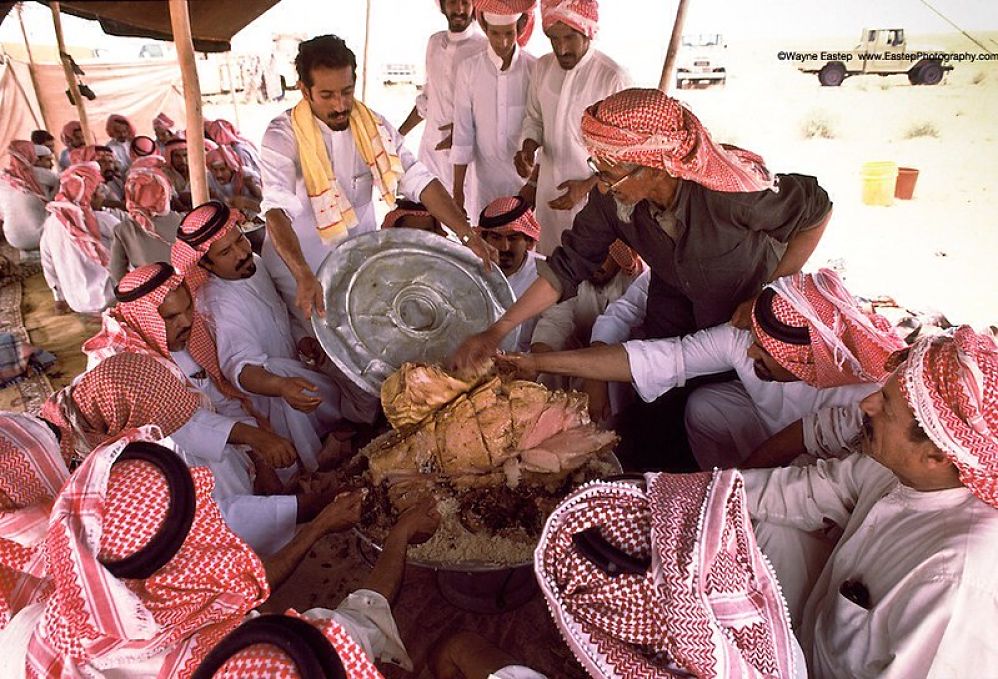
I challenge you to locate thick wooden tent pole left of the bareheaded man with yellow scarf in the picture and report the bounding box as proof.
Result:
[170,0,208,205]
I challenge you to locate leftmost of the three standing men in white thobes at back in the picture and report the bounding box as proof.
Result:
[399,0,487,194]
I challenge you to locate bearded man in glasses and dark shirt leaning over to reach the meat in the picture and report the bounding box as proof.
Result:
[453,89,832,468]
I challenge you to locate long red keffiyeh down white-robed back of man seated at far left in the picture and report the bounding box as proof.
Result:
[45,163,110,267]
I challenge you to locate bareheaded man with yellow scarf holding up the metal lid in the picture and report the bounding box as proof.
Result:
[260,35,495,421]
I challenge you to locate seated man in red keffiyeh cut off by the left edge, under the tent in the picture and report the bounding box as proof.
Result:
[0,139,50,250]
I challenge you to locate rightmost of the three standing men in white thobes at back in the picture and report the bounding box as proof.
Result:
[516,0,631,255]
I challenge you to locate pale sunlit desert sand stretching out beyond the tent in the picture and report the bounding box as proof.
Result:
[205,33,998,329]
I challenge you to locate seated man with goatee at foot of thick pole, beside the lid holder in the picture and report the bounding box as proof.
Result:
[172,201,345,472]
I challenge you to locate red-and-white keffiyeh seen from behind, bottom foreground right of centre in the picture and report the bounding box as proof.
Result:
[534,470,795,679]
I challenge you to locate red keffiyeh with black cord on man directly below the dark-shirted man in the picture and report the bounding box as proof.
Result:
[752,269,904,389]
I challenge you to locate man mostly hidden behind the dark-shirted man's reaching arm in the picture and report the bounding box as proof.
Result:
[530,240,644,389]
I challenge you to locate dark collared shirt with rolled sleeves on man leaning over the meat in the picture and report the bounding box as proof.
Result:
[538,174,832,337]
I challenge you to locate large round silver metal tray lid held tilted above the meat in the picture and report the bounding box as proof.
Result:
[312,229,516,395]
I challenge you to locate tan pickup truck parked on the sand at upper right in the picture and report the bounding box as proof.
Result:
[791,28,953,87]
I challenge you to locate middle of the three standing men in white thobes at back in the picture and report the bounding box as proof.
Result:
[450,12,537,219]
